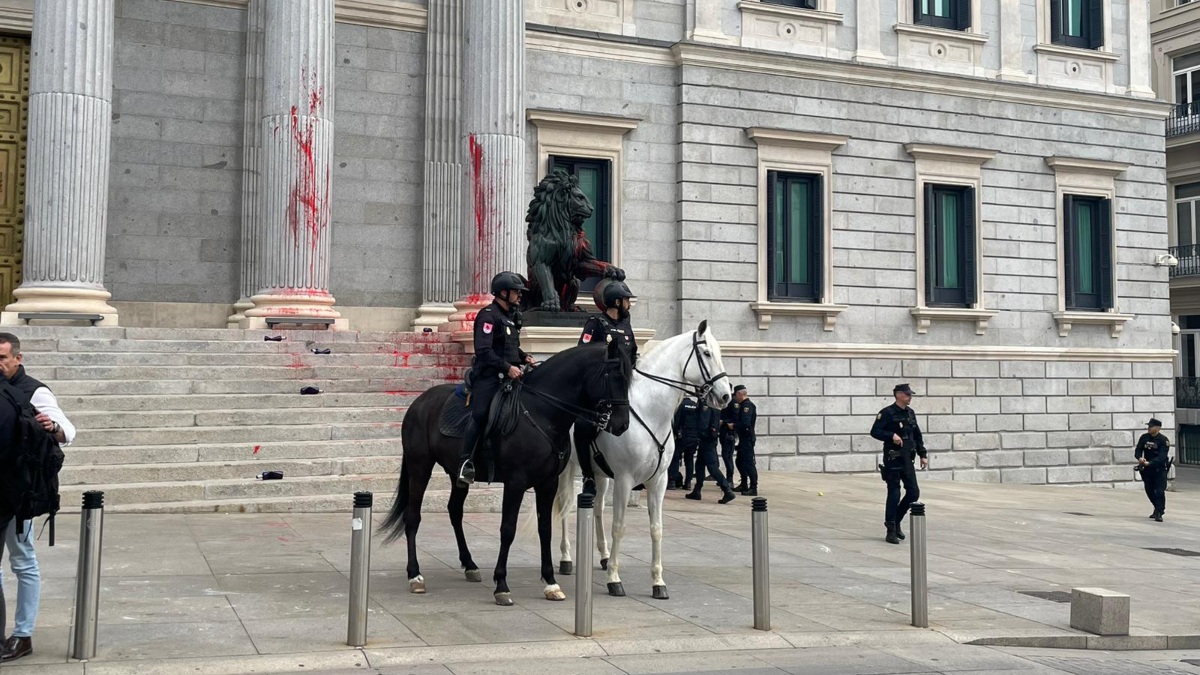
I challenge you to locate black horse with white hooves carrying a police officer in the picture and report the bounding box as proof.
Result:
[382,341,632,605]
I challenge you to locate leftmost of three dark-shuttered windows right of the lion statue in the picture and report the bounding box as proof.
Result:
[767,171,824,303]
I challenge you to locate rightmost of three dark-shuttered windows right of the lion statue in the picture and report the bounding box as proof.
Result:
[1063,195,1112,311]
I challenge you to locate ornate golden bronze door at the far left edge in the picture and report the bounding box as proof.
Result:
[0,36,29,306]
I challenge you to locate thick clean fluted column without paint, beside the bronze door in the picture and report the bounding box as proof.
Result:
[0,0,118,325]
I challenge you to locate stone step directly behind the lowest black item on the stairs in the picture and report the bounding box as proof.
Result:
[59,455,400,485]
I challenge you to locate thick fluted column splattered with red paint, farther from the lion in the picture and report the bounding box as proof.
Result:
[242,0,344,328]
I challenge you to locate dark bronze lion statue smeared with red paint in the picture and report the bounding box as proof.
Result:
[523,169,625,311]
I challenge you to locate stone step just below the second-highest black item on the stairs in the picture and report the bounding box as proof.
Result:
[28,350,469,371]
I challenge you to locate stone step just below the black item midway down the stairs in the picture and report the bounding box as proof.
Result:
[59,383,416,417]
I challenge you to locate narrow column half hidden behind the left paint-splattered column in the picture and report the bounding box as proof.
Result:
[227,0,266,328]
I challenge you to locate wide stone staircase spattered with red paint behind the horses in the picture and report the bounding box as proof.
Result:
[14,327,500,513]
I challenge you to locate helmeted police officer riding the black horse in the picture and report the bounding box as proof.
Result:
[458,271,535,488]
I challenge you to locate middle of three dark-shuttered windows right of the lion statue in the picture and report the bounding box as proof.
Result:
[925,184,976,307]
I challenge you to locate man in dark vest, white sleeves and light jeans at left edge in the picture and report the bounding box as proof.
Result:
[0,333,76,663]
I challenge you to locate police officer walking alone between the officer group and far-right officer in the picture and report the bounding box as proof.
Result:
[871,384,929,544]
